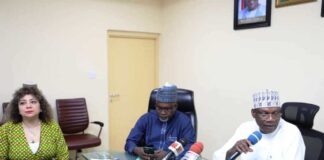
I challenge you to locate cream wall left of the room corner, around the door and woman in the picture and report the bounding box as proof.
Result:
[0,0,160,152]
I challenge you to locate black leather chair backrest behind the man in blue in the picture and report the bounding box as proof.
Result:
[148,88,197,134]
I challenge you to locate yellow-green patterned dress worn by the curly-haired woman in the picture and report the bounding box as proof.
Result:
[0,121,69,160]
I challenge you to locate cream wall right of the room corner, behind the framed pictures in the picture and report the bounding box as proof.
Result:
[160,0,324,158]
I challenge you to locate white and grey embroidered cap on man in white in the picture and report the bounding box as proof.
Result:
[253,89,281,108]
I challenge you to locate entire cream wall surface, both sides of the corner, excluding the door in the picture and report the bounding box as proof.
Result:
[0,0,324,158]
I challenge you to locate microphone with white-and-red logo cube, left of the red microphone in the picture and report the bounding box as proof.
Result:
[162,139,187,160]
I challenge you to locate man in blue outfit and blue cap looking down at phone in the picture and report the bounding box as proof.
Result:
[125,83,196,160]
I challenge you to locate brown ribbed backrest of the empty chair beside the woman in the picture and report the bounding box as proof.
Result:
[56,98,89,134]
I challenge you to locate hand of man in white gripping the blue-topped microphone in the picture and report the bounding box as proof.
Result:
[226,139,253,159]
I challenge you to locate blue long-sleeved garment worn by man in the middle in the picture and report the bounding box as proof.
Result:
[125,111,196,158]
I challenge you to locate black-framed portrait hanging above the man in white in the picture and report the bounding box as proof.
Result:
[234,0,271,30]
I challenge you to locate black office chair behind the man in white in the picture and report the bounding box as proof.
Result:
[281,102,324,160]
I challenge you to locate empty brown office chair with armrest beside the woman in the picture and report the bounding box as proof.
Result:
[56,98,104,159]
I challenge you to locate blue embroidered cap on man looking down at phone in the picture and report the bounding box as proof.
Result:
[156,83,177,103]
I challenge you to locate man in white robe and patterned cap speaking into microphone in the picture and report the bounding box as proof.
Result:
[213,90,305,160]
